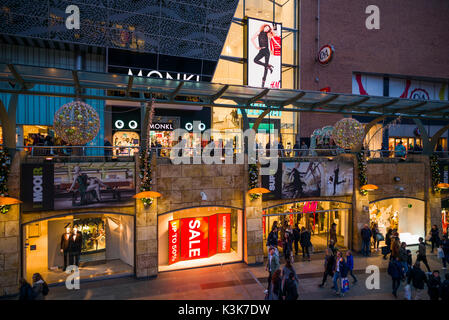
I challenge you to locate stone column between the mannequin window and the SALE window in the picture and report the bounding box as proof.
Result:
[135,199,158,278]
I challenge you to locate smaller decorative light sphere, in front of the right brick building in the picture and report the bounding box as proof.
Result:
[332,118,365,149]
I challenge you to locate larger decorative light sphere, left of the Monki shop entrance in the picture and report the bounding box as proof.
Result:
[53,101,100,146]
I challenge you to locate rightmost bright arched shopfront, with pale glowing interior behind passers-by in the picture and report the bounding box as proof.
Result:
[369,198,425,245]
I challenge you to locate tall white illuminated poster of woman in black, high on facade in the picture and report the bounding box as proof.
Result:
[247,18,282,89]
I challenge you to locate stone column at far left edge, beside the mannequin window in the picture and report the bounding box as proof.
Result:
[0,205,20,296]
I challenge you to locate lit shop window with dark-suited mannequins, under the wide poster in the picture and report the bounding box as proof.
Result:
[23,213,135,283]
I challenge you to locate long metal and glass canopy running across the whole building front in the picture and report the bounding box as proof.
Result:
[0,63,449,120]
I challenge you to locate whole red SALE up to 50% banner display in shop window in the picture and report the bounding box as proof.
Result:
[168,213,231,264]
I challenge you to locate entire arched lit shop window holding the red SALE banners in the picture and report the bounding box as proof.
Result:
[158,207,243,272]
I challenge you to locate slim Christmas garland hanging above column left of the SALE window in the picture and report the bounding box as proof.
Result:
[139,98,154,206]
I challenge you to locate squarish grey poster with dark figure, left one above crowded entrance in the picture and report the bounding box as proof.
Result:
[282,162,323,199]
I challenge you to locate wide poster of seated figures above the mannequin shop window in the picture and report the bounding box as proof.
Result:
[54,162,136,210]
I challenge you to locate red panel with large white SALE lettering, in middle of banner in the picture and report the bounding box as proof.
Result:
[180,217,209,260]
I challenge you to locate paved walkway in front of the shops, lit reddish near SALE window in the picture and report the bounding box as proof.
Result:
[7,250,446,300]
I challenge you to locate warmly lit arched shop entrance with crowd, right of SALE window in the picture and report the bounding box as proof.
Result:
[262,201,351,254]
